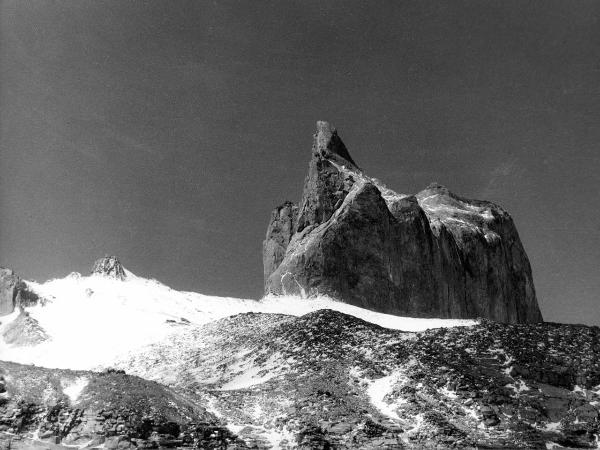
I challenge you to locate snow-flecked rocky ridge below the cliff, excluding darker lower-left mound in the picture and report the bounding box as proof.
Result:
[117,310,600,449]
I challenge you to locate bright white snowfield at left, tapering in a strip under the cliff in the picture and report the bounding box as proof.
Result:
[0,271,475,369]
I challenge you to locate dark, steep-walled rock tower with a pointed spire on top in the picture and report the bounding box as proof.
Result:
[264,122,542,323]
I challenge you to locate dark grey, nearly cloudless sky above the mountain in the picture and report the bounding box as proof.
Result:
[0,0,600,324]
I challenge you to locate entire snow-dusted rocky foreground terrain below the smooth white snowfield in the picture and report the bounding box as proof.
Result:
[0,290,600,449]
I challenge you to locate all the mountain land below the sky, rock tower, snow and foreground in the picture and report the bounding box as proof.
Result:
[0,122,600,450]
